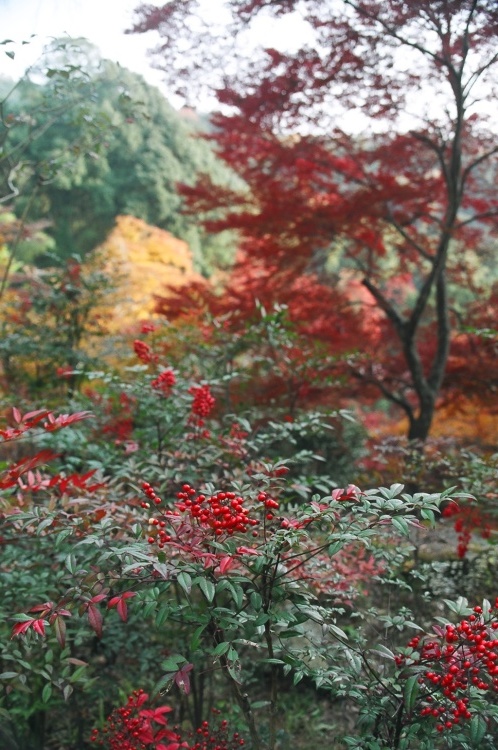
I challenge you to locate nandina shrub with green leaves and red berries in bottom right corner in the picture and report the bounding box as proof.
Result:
[346,597,498,750]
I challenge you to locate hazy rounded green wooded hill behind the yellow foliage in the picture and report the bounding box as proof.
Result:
[4,40,234,274]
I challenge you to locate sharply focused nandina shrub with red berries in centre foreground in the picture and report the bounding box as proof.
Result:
[1,414,476,748]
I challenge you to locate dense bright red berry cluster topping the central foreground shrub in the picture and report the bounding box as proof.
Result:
[176,484,259,536]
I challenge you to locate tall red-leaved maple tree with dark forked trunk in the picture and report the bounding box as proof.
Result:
[133,0,498,440]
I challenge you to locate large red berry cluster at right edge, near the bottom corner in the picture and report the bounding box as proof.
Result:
[395,598,498,732]
